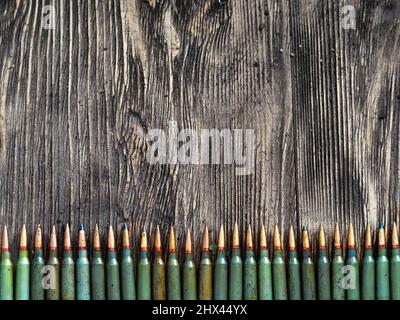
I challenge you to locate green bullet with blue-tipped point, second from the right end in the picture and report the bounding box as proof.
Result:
[376,223,390,300]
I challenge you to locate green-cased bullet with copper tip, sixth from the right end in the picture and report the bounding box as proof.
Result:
[317,226,331,300]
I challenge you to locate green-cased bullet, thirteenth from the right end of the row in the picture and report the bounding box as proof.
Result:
[214,225,228,300]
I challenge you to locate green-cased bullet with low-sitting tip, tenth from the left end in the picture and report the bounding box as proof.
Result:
[137,231,151,300]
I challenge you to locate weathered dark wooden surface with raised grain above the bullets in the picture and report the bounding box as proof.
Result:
[0,0,400,260]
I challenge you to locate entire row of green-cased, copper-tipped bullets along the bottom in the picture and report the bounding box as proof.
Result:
[0,224,400,300]
